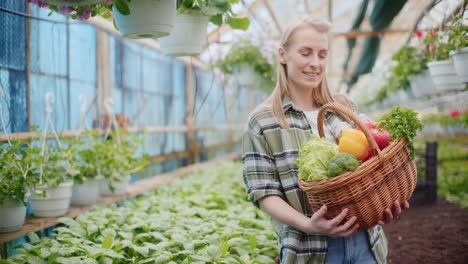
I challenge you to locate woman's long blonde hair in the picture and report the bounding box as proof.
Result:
[266,16,334,128]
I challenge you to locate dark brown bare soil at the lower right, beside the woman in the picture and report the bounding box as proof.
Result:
[384,198,468,264]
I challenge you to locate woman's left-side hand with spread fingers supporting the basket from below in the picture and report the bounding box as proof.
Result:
[302,205,359,237]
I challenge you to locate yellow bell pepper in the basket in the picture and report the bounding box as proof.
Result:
[338,129,369,161]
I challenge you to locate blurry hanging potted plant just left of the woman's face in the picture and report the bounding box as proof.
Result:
[215,40,276,92]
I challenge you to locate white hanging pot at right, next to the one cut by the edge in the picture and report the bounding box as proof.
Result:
[427,60,464,91]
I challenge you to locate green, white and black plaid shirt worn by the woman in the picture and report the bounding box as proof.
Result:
[242,96,387,264]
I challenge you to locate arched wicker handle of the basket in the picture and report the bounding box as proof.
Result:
[317,103,384,166]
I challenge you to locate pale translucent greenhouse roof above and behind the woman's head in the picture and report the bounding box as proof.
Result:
[194,0,463,97]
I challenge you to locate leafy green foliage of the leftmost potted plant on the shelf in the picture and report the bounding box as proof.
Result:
[0,140,39,205]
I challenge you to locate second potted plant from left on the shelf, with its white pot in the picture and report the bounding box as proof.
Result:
[29,136,79,217]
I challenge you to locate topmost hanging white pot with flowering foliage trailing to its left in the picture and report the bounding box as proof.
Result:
[28,0,176,38]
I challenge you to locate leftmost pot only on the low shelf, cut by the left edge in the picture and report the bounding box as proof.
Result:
[0,200,26,233]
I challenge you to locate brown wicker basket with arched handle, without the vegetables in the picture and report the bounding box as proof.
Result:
[299,103,417,231]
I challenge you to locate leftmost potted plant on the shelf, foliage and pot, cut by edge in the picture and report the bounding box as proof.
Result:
[0,140,38,233]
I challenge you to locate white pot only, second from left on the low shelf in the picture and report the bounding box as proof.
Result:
[29,181,73,217]
